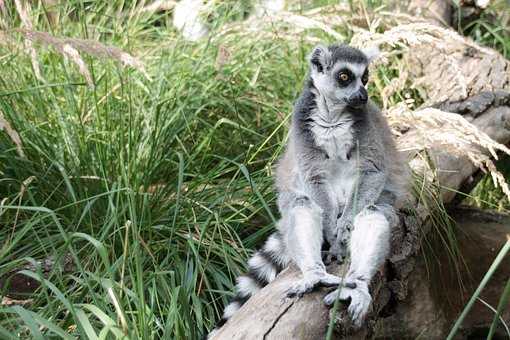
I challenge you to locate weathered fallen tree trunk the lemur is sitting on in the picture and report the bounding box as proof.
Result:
[213,1,510,340]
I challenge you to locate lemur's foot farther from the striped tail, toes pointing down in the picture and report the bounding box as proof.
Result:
[324,280,372,329]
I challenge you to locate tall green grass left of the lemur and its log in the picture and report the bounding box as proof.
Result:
[0,0,508,339]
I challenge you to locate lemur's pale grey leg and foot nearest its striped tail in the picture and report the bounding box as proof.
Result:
[282,196,341,296]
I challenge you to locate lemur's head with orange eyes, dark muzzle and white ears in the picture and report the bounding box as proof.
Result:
[310,45,370,109]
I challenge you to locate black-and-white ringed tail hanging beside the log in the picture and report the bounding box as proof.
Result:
[207,232,290,339]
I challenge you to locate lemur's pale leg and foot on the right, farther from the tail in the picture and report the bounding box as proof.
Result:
[324,204,397,328]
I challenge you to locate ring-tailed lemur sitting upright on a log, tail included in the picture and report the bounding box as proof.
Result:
[207,45,407,338]
